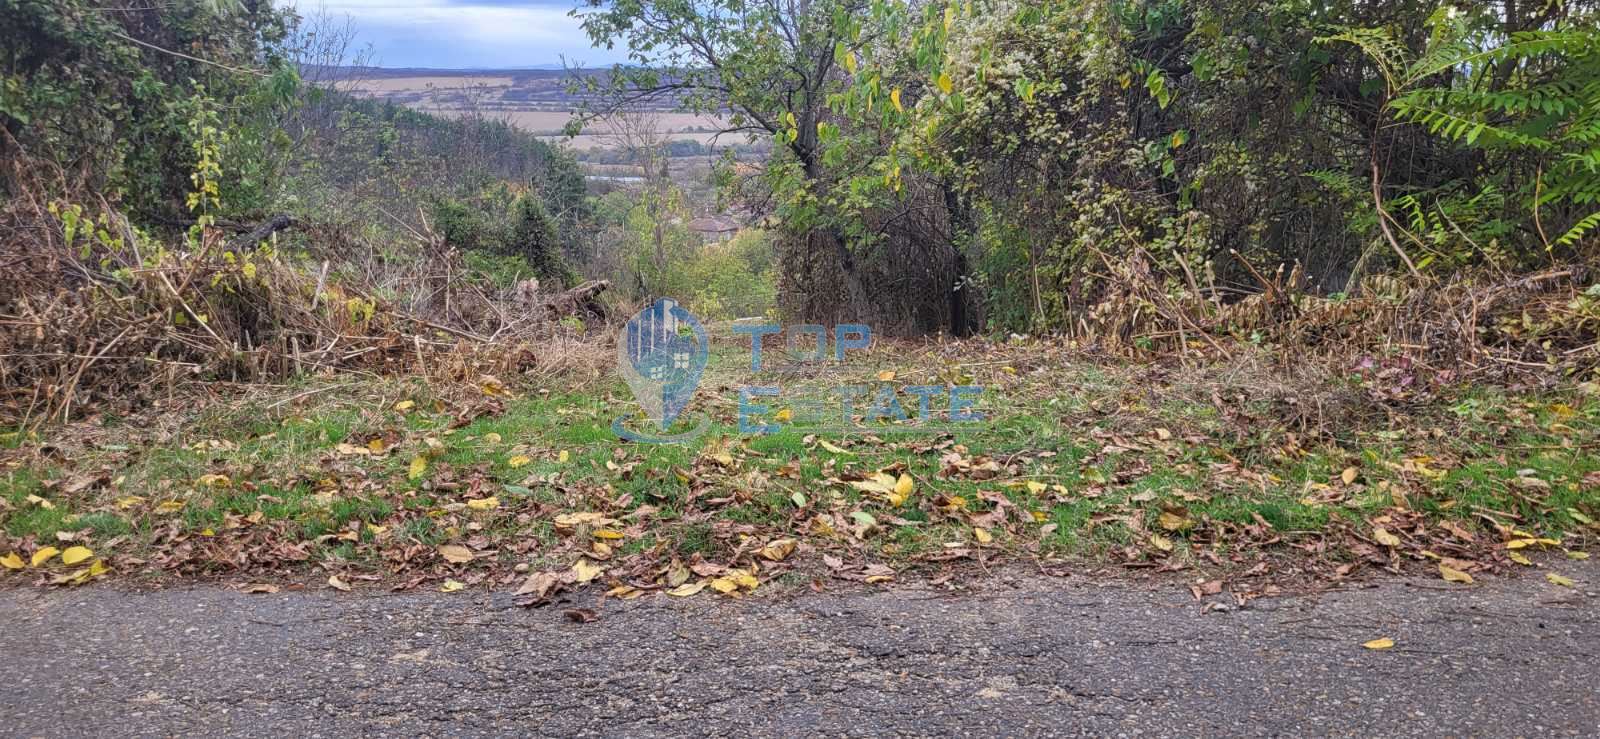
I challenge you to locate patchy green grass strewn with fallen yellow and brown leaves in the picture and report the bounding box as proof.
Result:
[0,344,1600,582]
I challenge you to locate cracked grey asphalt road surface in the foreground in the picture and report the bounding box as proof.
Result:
[0,560,1600,736]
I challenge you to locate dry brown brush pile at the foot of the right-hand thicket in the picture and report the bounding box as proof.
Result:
[1074,253,1600,379]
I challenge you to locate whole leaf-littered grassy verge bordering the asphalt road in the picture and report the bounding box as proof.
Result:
[0,342,1600,598]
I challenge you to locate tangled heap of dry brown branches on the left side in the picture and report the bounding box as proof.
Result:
[0,178,608,425]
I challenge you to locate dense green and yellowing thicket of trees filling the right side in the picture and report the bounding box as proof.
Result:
[582,0,1600,346]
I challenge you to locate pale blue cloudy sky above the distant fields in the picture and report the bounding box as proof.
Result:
[283,0,622,69]
